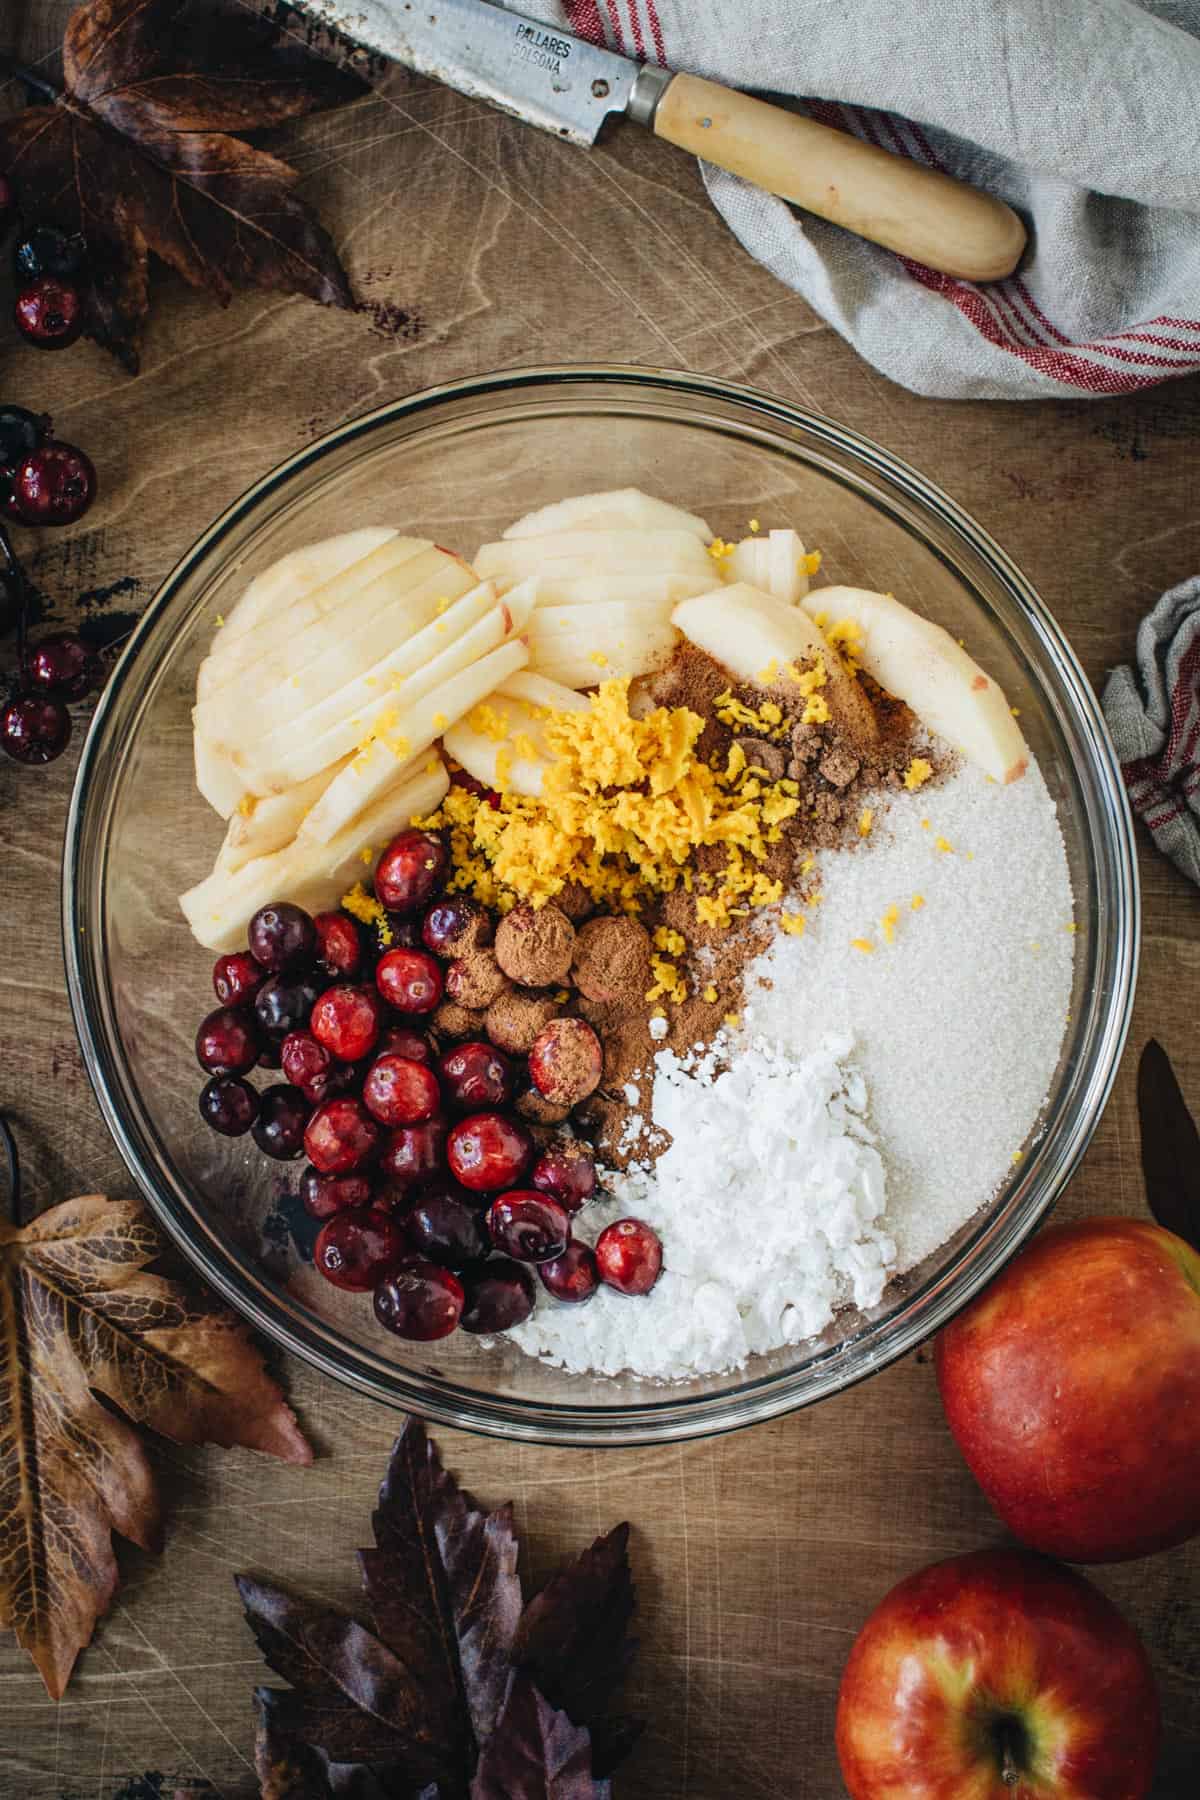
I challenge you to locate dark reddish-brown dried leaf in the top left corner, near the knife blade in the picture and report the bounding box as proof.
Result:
[0,0,365,371]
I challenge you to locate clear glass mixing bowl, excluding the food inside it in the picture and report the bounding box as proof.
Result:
[63,367,1139,1445]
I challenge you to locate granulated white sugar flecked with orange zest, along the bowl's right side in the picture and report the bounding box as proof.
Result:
[745,765,1074,1271]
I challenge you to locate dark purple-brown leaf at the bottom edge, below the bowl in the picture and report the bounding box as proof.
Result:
[237,1420,639,1800]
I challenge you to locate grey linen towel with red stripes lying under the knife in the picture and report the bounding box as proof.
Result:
[513,0,1200,400]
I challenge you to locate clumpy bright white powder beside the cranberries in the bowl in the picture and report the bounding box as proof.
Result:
[511,1035,896,1377]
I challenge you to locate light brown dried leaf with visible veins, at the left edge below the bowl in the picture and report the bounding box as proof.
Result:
[0,1193,313,1699]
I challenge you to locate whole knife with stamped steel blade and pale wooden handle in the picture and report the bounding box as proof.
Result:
[300,0,1025,281]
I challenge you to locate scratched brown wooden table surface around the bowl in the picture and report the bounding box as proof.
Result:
[0,0,1200,1800]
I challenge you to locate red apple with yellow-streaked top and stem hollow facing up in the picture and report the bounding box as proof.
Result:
[837,1550,1159,1800]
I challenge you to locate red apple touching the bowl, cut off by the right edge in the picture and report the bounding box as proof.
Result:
[937,1219,1200,1562]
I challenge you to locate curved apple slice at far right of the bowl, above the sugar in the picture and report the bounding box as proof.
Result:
[804,587,1029,781]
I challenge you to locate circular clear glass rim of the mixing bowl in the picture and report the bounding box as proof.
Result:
[61,364,1141,1447]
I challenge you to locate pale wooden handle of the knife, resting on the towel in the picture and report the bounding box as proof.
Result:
[653,76,1025,281]
